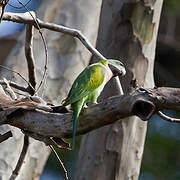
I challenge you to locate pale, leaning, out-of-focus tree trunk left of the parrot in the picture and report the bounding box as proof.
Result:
[0,0,101,180]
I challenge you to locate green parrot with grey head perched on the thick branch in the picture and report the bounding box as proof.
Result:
[63,59,126,148]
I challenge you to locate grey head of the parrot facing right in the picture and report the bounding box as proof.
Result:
[108,59,126,76]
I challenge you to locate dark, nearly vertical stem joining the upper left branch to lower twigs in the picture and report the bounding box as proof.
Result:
[25,24,36,95]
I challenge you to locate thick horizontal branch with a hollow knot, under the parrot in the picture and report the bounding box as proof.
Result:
[0,88,180,137]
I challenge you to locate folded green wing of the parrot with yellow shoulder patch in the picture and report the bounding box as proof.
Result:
[63,63,105,106]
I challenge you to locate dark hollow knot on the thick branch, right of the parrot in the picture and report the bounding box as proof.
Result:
[132,99,155,121]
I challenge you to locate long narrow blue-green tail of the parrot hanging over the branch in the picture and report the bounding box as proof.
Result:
[72,101,84,149]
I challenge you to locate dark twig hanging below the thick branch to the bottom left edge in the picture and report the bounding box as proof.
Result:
[9,135,29,180]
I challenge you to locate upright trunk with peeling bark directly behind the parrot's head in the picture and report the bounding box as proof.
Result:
[75,0,163,180]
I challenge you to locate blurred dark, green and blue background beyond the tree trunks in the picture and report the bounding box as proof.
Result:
[0,0,180,180]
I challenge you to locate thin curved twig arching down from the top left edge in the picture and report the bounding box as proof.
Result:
[17,0,48,93]
